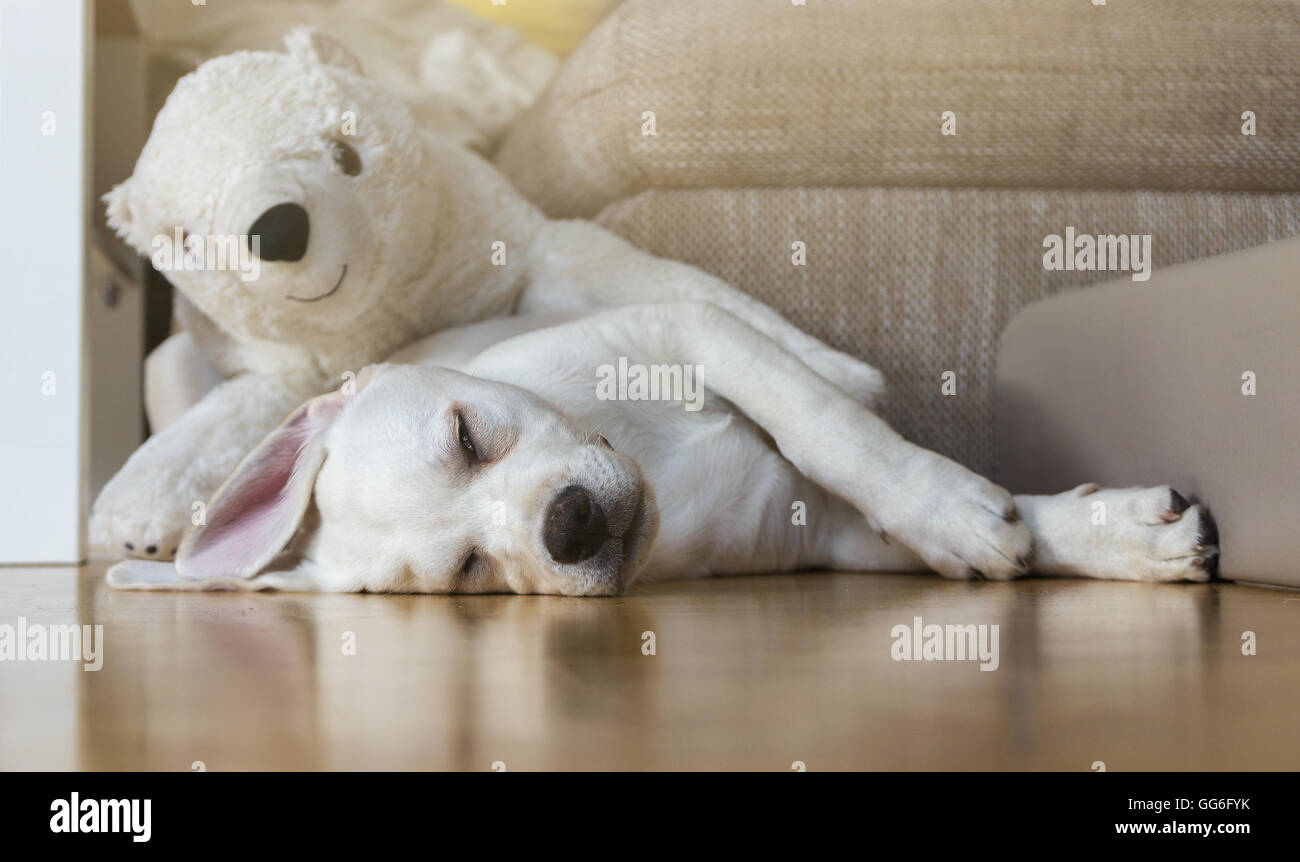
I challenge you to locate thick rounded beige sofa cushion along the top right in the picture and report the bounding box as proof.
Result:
[498,0,1300,216]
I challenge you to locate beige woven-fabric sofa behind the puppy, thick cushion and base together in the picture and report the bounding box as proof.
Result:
[497,0,1300,473]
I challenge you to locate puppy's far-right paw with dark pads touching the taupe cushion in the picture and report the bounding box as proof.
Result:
[1021,485,1219,581]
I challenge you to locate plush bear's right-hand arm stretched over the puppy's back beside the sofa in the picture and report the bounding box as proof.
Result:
[519,221,884,407]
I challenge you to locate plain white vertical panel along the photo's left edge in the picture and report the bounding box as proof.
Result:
[0,0,94,563]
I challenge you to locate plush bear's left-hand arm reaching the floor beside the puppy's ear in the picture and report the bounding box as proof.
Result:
[90,373,325,560]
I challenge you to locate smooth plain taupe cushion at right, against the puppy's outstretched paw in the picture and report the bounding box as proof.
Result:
[997,239,1300,586]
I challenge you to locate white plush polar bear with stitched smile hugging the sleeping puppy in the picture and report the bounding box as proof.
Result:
[90,31,881,559]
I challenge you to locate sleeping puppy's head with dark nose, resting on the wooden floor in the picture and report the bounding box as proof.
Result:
[177,365,658,595]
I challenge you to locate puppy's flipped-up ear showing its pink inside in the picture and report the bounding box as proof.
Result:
[176,391,347,580]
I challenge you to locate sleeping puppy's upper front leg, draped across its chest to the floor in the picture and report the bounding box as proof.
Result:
[485,303,1030,579]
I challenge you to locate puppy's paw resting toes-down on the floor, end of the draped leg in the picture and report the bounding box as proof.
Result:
[872,450,1032,581]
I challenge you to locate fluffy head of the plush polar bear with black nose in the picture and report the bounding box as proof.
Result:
[105,30,437,343]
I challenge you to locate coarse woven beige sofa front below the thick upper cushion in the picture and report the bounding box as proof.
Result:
[598,189,1300,473]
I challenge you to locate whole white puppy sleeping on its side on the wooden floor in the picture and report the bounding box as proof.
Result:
[108,302,1218,595]
